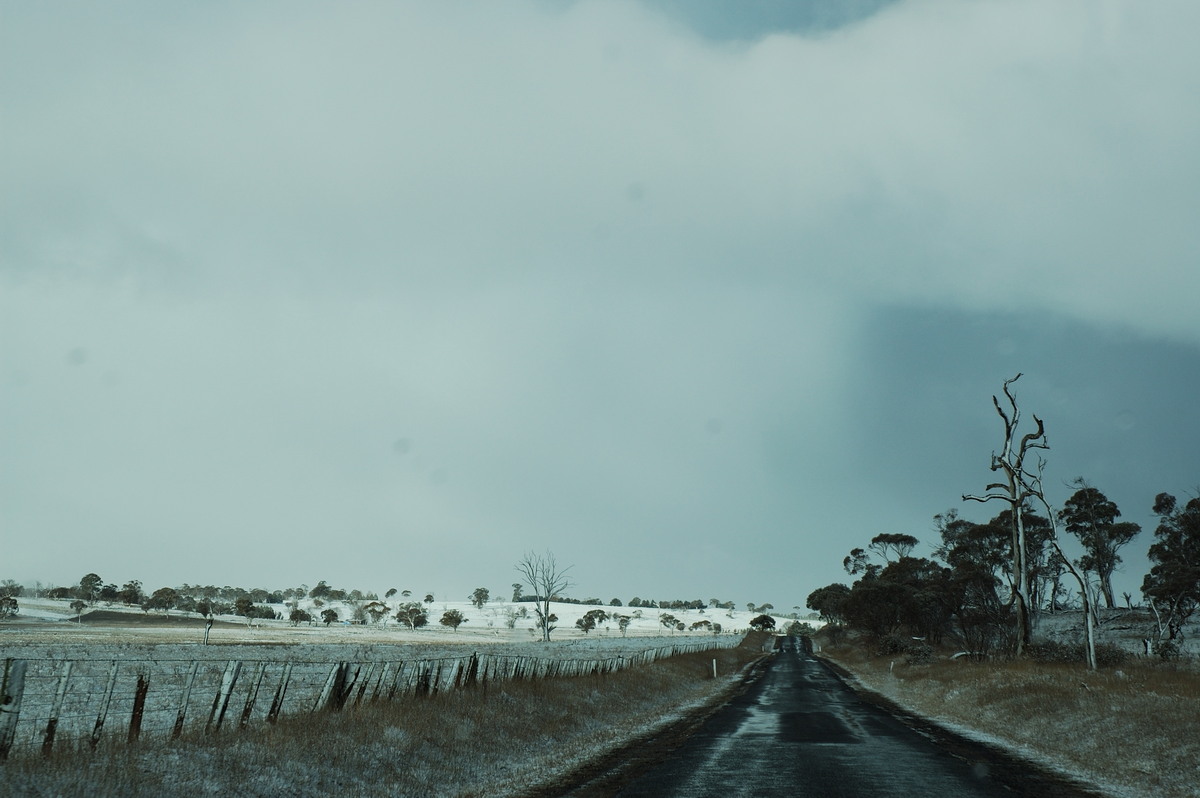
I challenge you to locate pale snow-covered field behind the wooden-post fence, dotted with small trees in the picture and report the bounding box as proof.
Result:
[0,599,801,746]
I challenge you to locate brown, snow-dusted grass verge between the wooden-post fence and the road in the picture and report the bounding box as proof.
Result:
[0,640,762,798]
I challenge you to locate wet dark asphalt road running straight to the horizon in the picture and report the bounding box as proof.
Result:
[565,638,1094,798]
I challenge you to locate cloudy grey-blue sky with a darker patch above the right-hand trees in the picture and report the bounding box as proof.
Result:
[0,0,1200,611]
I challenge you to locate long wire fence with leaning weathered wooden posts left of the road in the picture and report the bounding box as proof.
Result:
[0,637,742,761]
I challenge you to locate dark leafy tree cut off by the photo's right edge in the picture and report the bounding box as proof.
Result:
[1141,493,1200,642]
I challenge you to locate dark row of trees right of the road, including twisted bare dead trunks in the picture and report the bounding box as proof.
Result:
[806,374,1200,668]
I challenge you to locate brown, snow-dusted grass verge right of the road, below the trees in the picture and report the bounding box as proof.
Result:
[821,641,1200,798]
